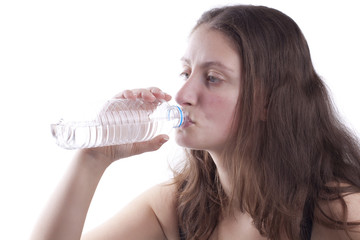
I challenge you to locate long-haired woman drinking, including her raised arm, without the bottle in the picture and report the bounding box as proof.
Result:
[33,6,360,240]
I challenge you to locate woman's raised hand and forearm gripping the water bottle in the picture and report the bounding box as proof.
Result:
[31,88,171,240]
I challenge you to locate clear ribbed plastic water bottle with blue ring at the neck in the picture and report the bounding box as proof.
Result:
[51,99,184,149]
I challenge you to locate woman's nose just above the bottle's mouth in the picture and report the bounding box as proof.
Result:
[175,76,200,106]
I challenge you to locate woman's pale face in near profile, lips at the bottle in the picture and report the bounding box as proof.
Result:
[175,24,241,156]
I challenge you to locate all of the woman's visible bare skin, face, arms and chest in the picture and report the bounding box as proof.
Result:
[31,25,360,240]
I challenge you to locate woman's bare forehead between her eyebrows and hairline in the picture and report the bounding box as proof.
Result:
[184,24,240,68]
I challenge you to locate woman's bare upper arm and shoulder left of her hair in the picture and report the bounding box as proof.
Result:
[81,182,179,240]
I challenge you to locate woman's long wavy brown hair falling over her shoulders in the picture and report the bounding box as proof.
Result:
[175,5,360,239]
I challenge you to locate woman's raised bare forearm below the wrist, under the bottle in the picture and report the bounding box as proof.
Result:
[31,152,107,240]
